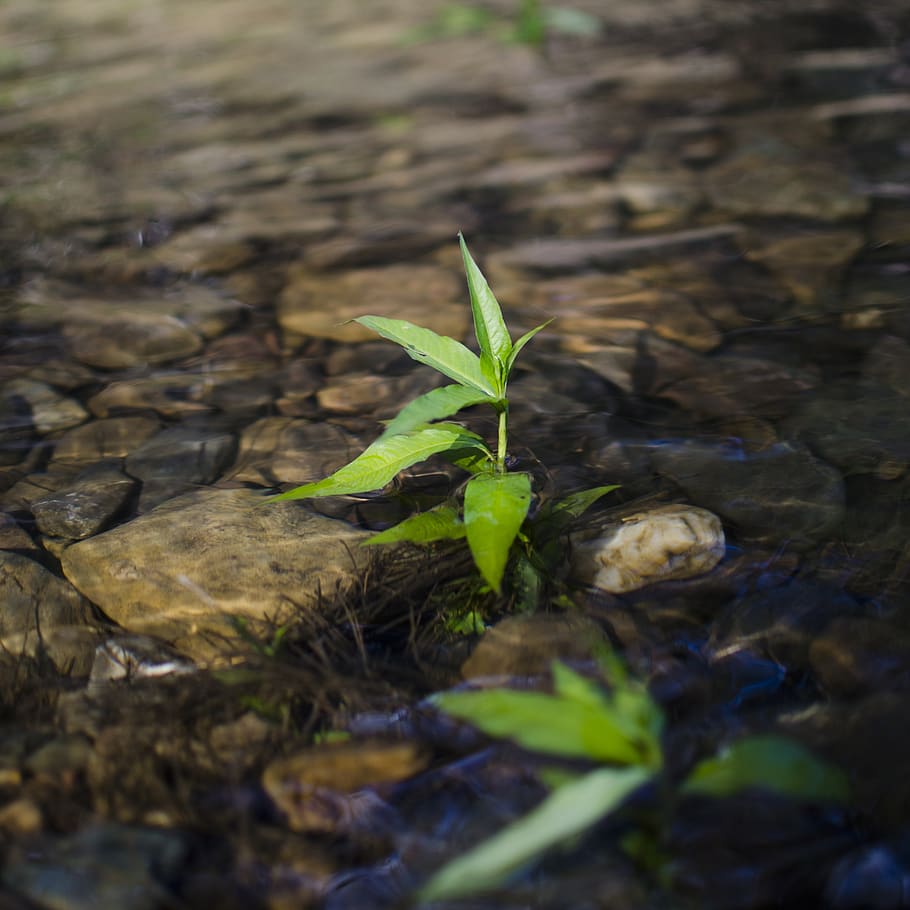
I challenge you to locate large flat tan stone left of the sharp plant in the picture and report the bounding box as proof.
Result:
[61,489,371,658]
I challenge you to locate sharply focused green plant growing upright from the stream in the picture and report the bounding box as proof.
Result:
[271,234,615,593]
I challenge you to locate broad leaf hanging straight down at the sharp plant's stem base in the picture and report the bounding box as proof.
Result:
[464,473,531,594]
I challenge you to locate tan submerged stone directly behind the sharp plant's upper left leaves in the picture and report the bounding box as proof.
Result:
[277,265,470,342]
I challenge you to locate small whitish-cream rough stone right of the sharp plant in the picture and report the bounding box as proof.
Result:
[572,503,724,594]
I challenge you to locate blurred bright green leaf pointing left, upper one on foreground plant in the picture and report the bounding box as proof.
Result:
[432,689,642,764]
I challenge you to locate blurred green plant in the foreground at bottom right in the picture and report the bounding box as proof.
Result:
[420,655,848,900]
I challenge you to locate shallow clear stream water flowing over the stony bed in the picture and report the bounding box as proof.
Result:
[0,0,910,908]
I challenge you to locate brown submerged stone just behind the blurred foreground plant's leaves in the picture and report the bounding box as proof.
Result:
[461,613,607,680]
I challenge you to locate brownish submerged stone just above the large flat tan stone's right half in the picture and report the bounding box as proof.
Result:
[226,417,365,486]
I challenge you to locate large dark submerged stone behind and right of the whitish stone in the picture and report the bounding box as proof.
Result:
[651,442,844,547]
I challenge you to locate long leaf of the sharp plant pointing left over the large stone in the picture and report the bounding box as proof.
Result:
[270,423,485,502]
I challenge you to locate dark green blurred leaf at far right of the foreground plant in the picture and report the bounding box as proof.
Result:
[682,736,850,802]
